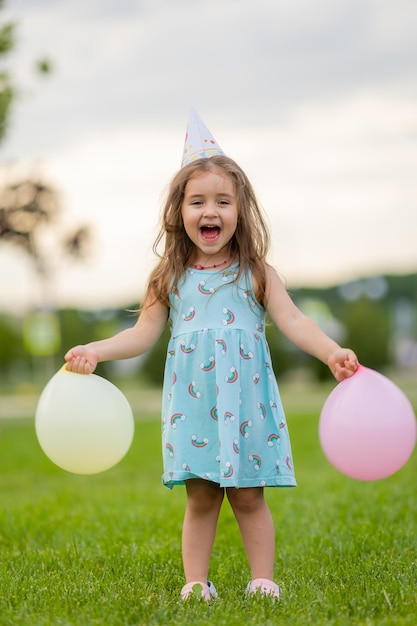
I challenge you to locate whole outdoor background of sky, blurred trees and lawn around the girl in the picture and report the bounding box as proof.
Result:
[0,0,417,626]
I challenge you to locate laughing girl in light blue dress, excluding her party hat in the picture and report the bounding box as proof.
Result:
[65,117,358,601]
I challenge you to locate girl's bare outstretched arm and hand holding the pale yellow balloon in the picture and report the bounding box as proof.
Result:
[64,296,168,374]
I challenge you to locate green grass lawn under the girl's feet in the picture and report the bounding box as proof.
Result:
[0,390,417,626]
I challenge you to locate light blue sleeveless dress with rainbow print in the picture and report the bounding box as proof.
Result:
[162,264,296,488]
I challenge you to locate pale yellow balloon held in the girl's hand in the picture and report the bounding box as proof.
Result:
[35,366,134,474]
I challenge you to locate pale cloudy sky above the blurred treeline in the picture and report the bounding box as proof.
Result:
[0,0,417,310]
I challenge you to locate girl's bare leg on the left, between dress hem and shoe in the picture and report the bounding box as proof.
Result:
[182,478,224,583]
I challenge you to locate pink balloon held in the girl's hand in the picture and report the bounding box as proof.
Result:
[319,365,417,480]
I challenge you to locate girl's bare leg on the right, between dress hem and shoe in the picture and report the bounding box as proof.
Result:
[227,487,275,580]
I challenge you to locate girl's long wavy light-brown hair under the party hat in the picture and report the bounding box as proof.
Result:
[146,156,270,306]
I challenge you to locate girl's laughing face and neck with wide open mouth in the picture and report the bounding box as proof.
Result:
[181,169,238,266]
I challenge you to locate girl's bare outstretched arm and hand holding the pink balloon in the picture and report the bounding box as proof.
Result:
[265,265,358,381]
